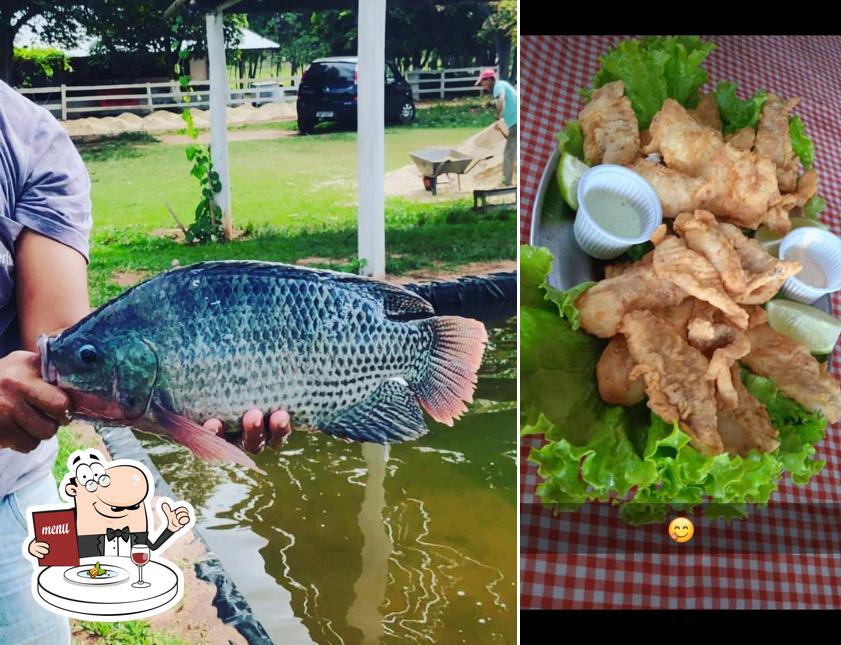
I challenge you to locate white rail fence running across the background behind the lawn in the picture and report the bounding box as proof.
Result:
[18,67,498,120]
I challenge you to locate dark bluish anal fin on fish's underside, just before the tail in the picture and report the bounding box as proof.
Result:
[317,381,428,443]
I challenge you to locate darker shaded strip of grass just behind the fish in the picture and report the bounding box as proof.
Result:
[89,203,517,306]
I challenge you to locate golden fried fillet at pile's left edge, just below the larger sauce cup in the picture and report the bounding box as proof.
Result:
[575,262,687,338]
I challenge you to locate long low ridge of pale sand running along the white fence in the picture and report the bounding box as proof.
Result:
[61,102,297,139]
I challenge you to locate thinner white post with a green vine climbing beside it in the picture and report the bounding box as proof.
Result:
[206,11,234,240]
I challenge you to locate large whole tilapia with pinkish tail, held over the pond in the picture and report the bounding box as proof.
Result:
[39,261,487,467]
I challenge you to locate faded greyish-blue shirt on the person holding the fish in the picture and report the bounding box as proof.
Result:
[0,81,92,499]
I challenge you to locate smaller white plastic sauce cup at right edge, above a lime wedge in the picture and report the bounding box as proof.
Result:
[780,226,841,305]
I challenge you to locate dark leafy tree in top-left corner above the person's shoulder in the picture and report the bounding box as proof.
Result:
[0,0,86,83]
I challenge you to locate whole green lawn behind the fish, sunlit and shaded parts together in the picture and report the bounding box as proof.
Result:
[81,106,516,305]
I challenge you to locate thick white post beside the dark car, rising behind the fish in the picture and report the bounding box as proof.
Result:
[356,0,386,279]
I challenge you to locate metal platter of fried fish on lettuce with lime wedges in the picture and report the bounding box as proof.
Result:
[520,37,841,524]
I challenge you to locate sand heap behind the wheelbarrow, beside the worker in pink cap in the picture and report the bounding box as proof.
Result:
[385,126,505,199]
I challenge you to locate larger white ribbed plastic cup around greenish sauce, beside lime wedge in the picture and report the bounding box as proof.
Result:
[573,164,663,260]
